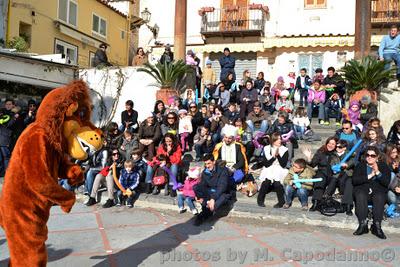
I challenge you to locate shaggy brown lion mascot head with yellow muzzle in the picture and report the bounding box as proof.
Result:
[35,81,102,160]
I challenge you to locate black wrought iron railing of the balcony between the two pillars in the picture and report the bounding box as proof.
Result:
[201,7,266,33]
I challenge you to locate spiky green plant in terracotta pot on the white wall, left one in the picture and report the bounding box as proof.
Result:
[138,60,192,103]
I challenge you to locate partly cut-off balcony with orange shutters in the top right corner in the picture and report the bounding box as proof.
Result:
[371,0,400,26]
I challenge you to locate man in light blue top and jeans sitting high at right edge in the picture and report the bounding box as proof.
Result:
[378,25,400,80]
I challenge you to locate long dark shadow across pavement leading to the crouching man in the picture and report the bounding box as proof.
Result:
[91,204,233,267]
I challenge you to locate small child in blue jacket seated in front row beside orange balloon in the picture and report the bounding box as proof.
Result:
[117,160,140,208]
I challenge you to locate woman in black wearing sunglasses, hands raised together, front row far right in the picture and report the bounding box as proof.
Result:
[353,146,390,239]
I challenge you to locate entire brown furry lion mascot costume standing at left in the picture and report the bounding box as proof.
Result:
[0,81,102,266]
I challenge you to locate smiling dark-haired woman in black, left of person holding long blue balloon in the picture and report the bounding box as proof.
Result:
[303,137,338,211]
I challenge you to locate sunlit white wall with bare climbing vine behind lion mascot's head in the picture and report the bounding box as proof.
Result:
[79,67,158,129]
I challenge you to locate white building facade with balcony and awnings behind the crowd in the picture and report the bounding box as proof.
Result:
[139,0,381,83]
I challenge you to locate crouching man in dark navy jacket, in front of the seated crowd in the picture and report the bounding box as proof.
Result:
[193,154,232,226]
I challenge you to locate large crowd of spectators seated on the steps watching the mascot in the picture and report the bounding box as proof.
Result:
[0,44,400,238]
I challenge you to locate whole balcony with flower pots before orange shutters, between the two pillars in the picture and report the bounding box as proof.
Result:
[199,5,268,37]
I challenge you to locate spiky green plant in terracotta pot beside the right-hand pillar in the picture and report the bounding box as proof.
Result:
[341,56,392,102]
